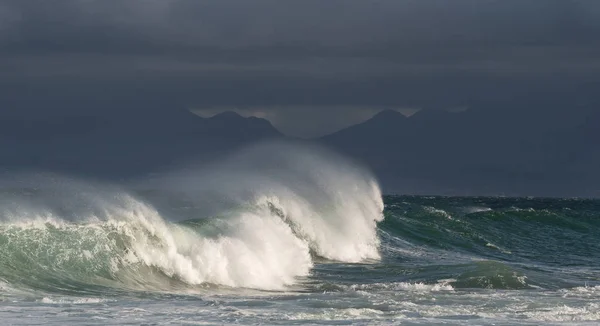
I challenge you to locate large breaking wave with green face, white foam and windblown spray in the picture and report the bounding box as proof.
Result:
[0,145,383,294]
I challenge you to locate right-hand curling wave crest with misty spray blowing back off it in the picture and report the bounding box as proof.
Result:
[145,142,383,262]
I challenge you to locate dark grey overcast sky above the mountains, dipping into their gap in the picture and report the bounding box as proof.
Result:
[0,0,600,137]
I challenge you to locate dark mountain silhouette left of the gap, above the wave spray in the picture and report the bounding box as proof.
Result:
[0,109,282,177]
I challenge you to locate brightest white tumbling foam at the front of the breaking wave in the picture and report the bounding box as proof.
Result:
[118,201,312,289]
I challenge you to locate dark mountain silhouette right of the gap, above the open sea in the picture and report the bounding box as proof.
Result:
[319,110,600,196]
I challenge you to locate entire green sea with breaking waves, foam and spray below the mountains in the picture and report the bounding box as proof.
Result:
[0,145,600,325]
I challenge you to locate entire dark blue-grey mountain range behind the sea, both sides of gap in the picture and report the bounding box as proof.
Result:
[0,105,600,196]
